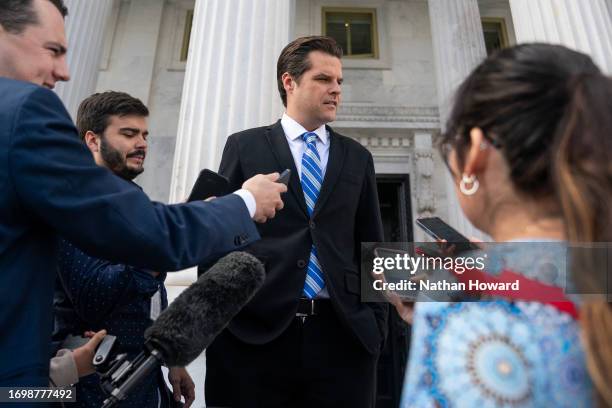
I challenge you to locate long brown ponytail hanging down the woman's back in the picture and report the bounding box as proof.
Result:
[553,75,612,406]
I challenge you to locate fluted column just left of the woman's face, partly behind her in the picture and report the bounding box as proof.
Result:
[428,0,487,237]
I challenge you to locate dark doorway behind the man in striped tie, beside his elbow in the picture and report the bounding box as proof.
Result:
[376,174,413,408]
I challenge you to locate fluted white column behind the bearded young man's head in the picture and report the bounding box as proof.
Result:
[55,0,113,119]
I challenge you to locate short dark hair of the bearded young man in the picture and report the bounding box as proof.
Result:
[76,91,149,139]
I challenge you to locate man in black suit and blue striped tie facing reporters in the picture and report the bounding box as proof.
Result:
[205,37,387,407]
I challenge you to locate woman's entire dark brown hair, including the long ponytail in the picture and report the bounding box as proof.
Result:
[440,44,612,405]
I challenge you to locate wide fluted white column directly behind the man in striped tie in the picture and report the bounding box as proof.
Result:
[170,0,294,202]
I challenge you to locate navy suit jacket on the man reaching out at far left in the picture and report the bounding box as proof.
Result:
[0,78,259,386]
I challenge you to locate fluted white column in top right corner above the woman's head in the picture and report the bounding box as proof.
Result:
[510,0,612,74]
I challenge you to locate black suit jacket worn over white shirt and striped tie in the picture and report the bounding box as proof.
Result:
[219,121,387,353]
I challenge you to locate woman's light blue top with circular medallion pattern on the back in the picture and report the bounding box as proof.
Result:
[401,243,595,408]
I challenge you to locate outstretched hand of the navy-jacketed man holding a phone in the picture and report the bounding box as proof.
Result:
[242,173,287,222]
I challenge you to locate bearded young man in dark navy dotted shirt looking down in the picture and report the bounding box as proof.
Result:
[53,91,195,408]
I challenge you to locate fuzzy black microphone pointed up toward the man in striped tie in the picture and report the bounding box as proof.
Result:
[99,252,265,408]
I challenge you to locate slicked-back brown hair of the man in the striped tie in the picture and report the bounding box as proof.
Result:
[276,35,342,106]
